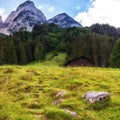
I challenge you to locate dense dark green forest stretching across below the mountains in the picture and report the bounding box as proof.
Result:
[0,24,120,67]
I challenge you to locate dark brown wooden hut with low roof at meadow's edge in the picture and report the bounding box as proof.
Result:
[65,56,94,67]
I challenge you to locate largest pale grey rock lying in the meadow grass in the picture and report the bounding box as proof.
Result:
[83,91,110,103]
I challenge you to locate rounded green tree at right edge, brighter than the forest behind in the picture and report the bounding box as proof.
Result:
[110,39,120,68]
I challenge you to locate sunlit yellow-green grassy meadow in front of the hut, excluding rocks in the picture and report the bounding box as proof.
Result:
[0,64,120,120]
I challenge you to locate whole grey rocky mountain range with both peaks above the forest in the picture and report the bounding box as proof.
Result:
[0,0,82,35]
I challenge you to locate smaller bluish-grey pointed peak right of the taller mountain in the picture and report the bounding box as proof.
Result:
[47,13,82,28]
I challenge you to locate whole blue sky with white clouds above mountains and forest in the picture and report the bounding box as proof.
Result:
[0,0,120,27]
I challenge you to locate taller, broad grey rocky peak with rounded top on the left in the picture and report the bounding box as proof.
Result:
[4,1,46,32]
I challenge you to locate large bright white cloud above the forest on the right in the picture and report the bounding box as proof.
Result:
[75,0,120,27]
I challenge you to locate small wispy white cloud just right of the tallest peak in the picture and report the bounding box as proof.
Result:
[38,4,55,13]
